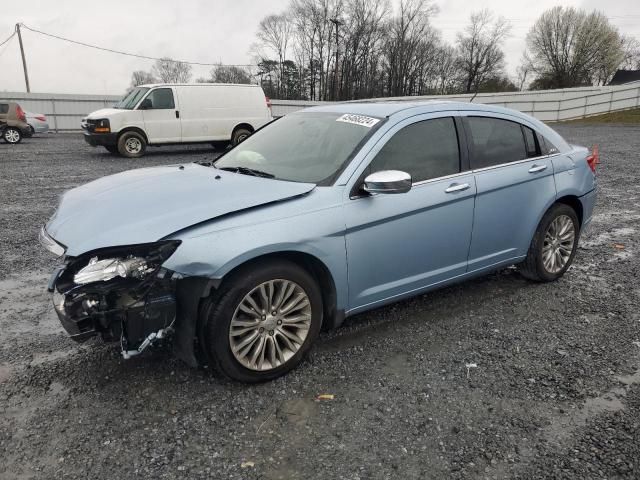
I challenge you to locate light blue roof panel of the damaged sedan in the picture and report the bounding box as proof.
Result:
[305,100,527,118]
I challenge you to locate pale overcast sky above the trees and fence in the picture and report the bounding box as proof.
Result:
[0,0,640,95]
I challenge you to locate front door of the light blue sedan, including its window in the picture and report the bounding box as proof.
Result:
[345,117,476,312]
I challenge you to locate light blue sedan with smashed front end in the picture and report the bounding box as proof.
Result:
[40,102,598,382]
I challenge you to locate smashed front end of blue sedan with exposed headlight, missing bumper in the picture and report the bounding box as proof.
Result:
[46,236,182,358]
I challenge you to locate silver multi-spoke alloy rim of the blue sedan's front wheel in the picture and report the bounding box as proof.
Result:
[229,279,311,371]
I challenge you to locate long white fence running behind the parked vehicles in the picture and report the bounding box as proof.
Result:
[0,82,640,131]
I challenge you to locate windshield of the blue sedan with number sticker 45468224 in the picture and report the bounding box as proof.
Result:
[215,112,381,184]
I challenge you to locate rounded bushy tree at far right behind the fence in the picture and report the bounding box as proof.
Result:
[527,7,624,88]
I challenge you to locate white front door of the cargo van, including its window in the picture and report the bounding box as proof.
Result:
[138,87,182,143]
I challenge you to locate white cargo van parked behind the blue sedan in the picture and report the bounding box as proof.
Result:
[82,83,272,158]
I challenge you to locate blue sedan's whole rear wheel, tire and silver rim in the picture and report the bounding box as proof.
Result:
[520,203,580,282]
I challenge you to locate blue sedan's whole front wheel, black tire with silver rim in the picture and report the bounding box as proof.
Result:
[202,260,322,383]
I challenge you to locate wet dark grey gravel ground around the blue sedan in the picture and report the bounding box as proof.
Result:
[0,125,640,480]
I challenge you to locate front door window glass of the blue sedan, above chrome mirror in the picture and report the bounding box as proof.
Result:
[370,117,460,183]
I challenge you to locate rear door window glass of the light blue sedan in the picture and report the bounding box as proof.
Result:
[467,117,527,169]
